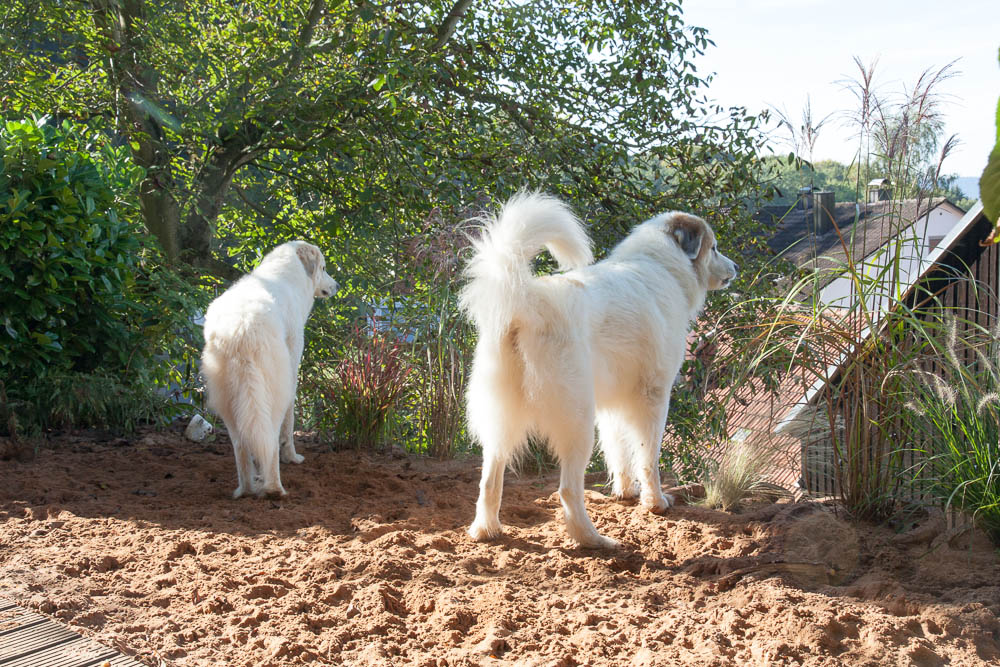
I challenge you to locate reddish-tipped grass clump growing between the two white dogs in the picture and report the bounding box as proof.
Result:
[329,323,412,449]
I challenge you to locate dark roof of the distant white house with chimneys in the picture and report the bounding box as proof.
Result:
[759,197,965,286]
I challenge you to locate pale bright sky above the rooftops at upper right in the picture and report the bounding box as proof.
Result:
[682,0,1000,177]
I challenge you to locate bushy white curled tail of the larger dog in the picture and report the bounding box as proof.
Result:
[459,192,594,336]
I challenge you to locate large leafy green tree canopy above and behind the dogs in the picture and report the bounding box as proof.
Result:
[0,0,762,290]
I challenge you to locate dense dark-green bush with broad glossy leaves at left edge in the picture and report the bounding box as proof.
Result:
[0,120,141,385]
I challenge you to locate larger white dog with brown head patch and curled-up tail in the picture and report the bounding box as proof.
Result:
[461,194,736,547]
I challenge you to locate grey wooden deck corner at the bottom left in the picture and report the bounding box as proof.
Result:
[0,598,143,667]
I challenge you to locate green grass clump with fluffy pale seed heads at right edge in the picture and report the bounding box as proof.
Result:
[899,318,1000,545]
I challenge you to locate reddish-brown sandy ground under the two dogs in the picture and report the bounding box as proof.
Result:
[0,432,1000,667]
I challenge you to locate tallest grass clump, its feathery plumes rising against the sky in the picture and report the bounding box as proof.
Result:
[751,60,955,520]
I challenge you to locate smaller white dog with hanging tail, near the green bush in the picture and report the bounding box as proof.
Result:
[201,241,337,498]
